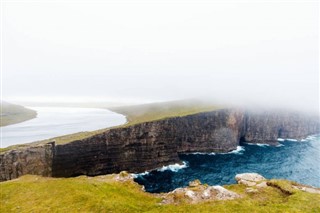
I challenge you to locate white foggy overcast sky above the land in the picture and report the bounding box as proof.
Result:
[1,0,319,111]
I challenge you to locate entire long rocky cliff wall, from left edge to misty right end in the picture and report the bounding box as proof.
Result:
[0,109,320,181]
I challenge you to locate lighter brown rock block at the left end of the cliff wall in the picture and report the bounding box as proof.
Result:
[0,143,54,181]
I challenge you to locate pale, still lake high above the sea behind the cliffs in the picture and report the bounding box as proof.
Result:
[0,107,126,147]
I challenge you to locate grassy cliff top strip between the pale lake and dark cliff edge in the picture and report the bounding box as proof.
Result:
[0,100,222,153]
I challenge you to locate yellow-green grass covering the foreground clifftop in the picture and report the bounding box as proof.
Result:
[0,175,320,212]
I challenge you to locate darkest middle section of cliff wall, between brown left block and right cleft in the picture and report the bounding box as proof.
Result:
[52,110,243,177]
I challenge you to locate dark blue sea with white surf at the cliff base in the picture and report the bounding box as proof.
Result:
[135,136,320,192]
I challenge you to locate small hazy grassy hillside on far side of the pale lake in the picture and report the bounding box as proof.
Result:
[0,101,37,126]
